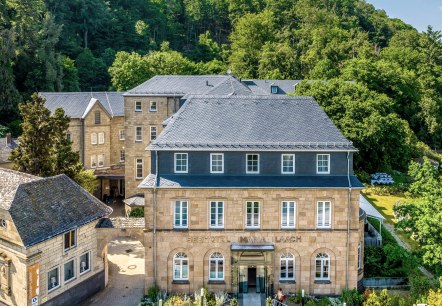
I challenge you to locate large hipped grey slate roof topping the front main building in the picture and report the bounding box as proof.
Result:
[148,95,356,151]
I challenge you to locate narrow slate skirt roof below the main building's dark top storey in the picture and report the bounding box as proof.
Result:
[138,174,364,188]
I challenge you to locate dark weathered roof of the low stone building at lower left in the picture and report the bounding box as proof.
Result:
[0,169,112,247]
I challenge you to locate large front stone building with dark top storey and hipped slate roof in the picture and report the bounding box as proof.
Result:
[140,94,364,295]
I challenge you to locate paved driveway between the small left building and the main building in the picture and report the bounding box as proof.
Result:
[82,238,144,306]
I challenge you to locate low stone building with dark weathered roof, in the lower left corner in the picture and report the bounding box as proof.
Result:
[0,169,112,306]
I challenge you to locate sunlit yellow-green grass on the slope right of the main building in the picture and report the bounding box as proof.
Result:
[363,189,419,251]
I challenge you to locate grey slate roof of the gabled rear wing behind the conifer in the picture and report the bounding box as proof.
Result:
[40,92,124,118]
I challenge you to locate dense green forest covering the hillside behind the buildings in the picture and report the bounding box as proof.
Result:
[0,0,442,173]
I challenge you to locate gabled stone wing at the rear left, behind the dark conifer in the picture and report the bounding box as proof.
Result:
[40,92,125,200]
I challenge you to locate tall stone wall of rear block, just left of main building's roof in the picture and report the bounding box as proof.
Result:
[124,96,180,197]
